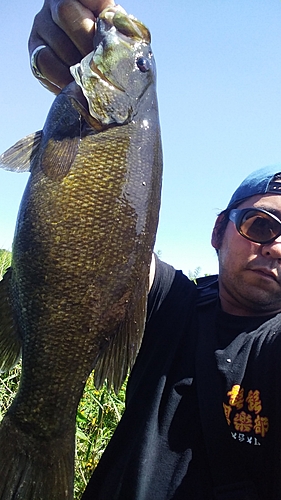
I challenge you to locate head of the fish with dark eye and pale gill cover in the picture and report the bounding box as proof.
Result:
[71,8,156,125]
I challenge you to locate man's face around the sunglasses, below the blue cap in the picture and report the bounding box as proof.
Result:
[212,194,281,316]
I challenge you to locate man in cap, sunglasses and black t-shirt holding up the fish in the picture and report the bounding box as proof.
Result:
[29,0,281,500]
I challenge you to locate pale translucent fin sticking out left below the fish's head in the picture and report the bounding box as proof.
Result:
[0,130,42,172]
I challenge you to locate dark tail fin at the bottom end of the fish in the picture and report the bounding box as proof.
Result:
[0,415,75,500]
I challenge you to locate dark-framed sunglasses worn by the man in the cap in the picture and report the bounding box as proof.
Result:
[228,208,281,244]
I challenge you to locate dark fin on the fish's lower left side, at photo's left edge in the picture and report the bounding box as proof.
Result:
[0,267,21,371]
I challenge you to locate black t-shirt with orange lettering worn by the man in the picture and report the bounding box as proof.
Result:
[83,260,281,500]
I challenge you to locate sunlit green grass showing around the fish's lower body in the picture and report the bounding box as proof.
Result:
[0,249,126,500]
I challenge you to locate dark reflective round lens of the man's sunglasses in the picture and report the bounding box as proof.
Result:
[240,212,280,243]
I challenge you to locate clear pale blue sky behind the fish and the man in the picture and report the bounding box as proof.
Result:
[0,0,281,273]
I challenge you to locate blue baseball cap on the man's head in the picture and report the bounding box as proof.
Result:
[227,164,281,208]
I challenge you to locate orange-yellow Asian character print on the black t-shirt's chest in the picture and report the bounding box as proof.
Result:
[223,384,269,444]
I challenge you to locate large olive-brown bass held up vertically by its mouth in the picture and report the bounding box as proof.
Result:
[0,8,163,500]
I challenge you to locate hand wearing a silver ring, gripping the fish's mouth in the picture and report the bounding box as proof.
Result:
[28,0,115,94]
